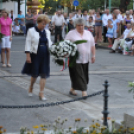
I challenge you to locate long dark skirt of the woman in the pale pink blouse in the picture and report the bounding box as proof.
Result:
[69,63,89,91]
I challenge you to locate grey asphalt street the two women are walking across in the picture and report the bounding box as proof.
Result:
[0,36,134,132]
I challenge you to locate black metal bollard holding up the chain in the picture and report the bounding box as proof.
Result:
[102,80,109,127]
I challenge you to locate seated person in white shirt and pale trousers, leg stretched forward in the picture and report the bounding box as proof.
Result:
[110,23,131,53]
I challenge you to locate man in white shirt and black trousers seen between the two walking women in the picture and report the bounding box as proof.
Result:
[52,10,65,43]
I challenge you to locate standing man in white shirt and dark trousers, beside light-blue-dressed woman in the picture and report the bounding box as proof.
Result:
[102,9,112,42]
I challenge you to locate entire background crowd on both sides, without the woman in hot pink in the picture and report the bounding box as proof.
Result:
[0,9,134,55]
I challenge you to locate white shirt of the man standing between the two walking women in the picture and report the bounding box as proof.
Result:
[52,15,65,26]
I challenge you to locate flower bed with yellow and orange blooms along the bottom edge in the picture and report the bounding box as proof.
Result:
[0,117,134,134]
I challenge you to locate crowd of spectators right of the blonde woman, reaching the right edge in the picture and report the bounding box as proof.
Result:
[51,9,134,56]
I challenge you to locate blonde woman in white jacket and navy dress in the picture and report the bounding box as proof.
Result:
[22,14,52,101]
